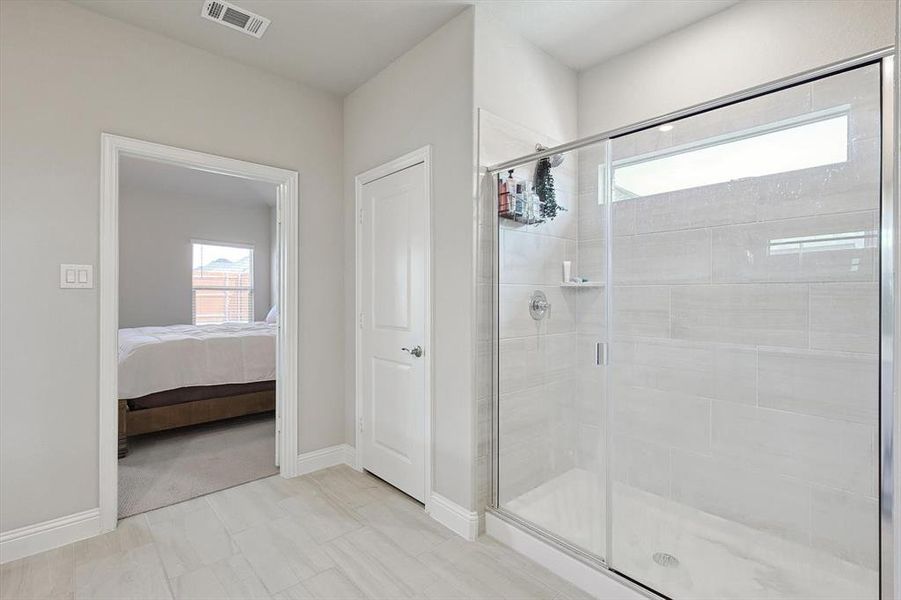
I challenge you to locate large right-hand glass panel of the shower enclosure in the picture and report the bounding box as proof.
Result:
[607,65,880,599]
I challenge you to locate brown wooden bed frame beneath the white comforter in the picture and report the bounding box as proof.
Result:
[119,390,275,458]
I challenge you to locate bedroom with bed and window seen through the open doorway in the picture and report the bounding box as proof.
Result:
[117,157,278,518]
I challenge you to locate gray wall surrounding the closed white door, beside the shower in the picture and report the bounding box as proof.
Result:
[344,9,475,507]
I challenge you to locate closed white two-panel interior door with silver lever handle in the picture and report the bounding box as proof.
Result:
[359,163,429,502]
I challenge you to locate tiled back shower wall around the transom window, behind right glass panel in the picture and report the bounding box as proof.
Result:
[596,66,879,568]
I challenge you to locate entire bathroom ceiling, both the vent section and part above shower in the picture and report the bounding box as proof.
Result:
[72,0,738,95]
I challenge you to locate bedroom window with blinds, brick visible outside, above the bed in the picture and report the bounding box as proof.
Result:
[191,241,253,325]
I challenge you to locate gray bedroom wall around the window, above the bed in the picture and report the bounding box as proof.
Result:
[119,188,274,327]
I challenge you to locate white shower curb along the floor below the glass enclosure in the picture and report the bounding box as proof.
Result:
[485,512,655,600]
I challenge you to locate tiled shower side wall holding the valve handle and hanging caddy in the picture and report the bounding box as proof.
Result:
[477,110,578,506]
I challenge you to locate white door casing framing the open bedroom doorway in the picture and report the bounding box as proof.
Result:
[98,133,301,533]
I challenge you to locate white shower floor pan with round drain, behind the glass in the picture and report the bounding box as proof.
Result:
[504,469,879,600]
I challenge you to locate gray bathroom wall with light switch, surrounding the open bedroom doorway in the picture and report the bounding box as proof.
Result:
[0,2,344,531]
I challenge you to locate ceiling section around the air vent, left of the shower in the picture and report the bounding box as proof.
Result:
[72,0,465,95]
